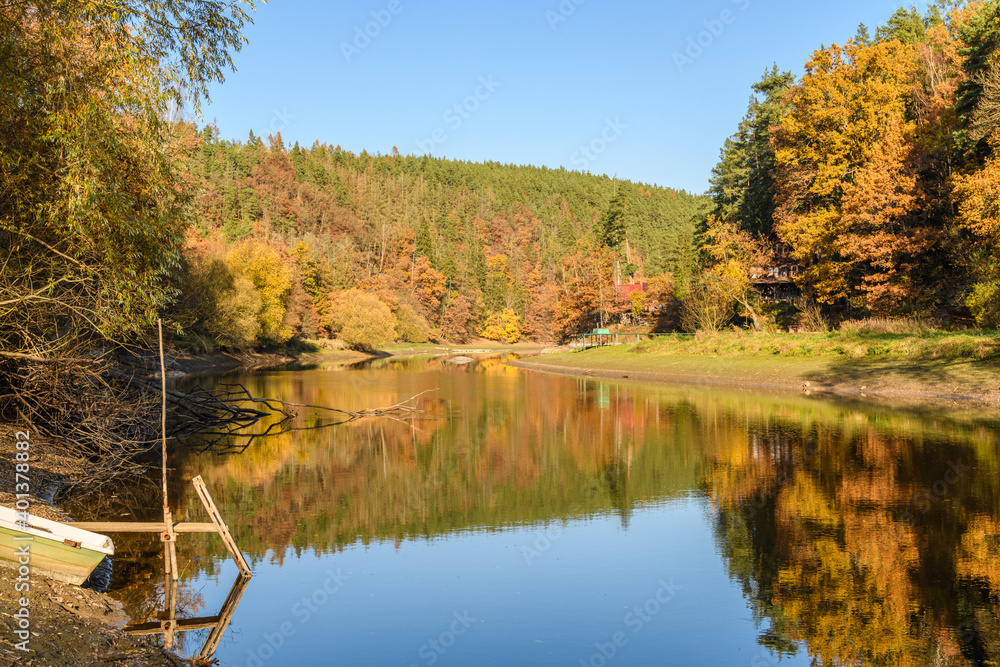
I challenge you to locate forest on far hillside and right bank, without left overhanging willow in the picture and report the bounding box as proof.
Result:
[174,2,1000,352]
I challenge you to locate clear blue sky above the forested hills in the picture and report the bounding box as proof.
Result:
[203,0,923,193]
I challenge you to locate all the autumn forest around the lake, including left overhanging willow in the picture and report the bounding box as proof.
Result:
[9,0,1000,354]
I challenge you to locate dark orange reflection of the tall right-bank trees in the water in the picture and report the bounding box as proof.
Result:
[706,410,1000,665]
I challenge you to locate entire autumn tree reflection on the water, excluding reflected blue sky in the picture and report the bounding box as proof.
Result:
[88,360,1000,665]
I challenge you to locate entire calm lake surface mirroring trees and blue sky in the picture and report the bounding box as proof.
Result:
[78,358,1000,667]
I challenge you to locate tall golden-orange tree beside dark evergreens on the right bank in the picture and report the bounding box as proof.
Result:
[775,41,936,312]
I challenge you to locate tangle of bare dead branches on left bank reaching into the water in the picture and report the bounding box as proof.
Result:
[0,334,436,470]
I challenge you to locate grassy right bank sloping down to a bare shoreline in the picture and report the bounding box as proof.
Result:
[512,332,1000,404]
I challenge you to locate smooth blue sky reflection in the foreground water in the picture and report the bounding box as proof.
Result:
[191,497,808,665]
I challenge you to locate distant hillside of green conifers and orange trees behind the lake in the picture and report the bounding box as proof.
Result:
[173,132,707,347]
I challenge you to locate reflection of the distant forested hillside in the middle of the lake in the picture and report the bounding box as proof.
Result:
[170,358,697,572]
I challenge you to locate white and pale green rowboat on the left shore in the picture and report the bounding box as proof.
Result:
[0,507,115,586]
